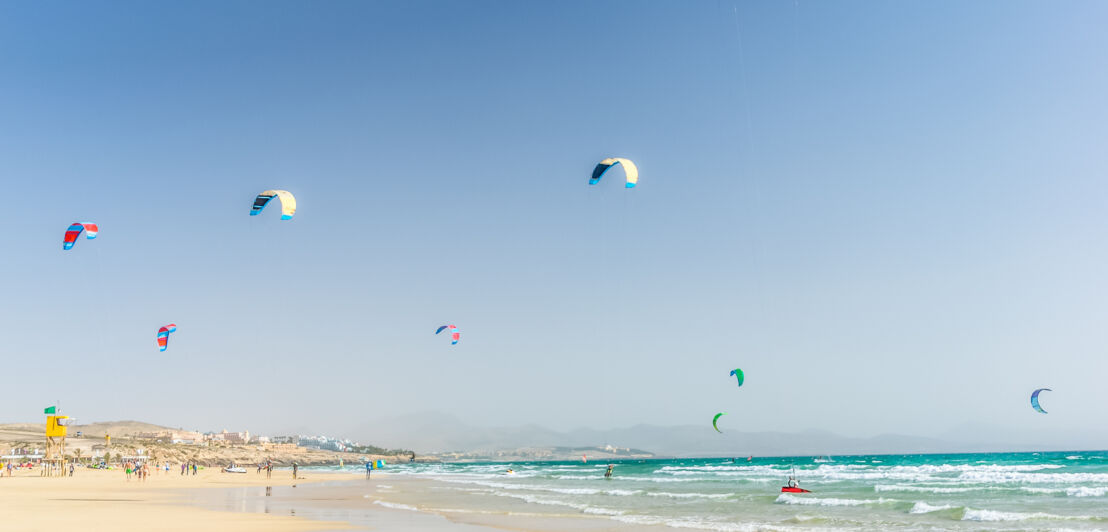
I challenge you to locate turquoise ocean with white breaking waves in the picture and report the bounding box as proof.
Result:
[358,451,1108,531]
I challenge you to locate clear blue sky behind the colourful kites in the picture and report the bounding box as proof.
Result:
[0,0,1108,444]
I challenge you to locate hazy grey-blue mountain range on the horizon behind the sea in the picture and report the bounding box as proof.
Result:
[348,412,1106,457]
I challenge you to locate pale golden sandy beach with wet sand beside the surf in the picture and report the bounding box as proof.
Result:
[0,469,647,532]
